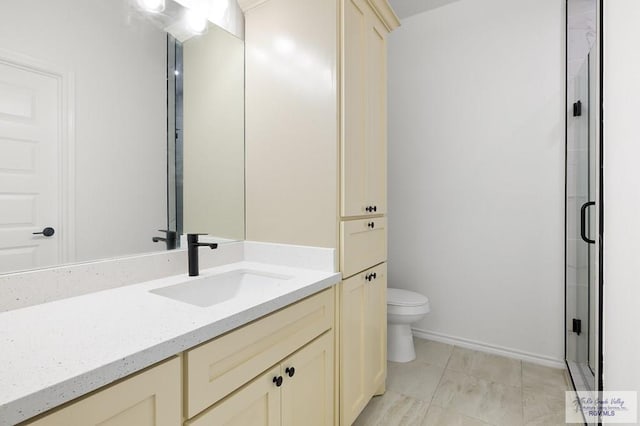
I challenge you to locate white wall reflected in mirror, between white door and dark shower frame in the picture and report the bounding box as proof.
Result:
[0,0,167,260]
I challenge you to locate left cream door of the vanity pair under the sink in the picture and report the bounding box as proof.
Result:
[185,365,281,426]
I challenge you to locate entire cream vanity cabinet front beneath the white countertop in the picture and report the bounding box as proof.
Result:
[21,287,336,426]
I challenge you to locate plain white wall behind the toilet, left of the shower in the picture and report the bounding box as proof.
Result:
[389,0,565,363]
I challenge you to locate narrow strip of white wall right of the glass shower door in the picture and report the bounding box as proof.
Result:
[603,0,640,412]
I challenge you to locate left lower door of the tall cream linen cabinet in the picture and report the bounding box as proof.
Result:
[340,272,370,425]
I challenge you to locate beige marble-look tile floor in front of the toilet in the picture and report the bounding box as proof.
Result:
[354,339,571,426]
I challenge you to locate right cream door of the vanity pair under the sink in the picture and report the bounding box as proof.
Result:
[281,332,334,426]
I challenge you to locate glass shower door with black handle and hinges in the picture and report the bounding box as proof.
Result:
[565,53,599,390]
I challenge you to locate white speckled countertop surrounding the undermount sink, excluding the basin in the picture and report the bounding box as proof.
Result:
[0,261,340,426]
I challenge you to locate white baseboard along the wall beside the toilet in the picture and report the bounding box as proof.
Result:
[413,328,566,369]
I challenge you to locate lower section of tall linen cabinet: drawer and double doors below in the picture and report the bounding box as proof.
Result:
[339,217,387,425]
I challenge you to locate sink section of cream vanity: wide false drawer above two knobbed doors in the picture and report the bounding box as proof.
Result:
[185,288,335,426]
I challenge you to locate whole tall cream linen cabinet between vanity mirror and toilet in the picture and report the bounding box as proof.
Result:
[239,0,399,425]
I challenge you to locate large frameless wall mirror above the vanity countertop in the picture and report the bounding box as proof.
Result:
[0,0,244,273]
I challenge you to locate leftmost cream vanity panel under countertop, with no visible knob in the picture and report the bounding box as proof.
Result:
[29,358,182,426]
